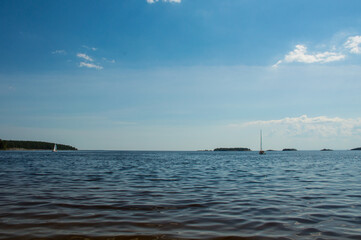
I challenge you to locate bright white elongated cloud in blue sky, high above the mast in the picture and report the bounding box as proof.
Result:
[273,44,346,67]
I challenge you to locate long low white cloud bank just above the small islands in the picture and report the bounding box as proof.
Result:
[239,115,361,137]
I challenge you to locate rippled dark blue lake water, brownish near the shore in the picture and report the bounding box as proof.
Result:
[0,151,361,240]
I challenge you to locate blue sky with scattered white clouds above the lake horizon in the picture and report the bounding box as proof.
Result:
[0,0,361,150]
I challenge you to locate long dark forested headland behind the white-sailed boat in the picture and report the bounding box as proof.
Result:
[0,139,78,150]
